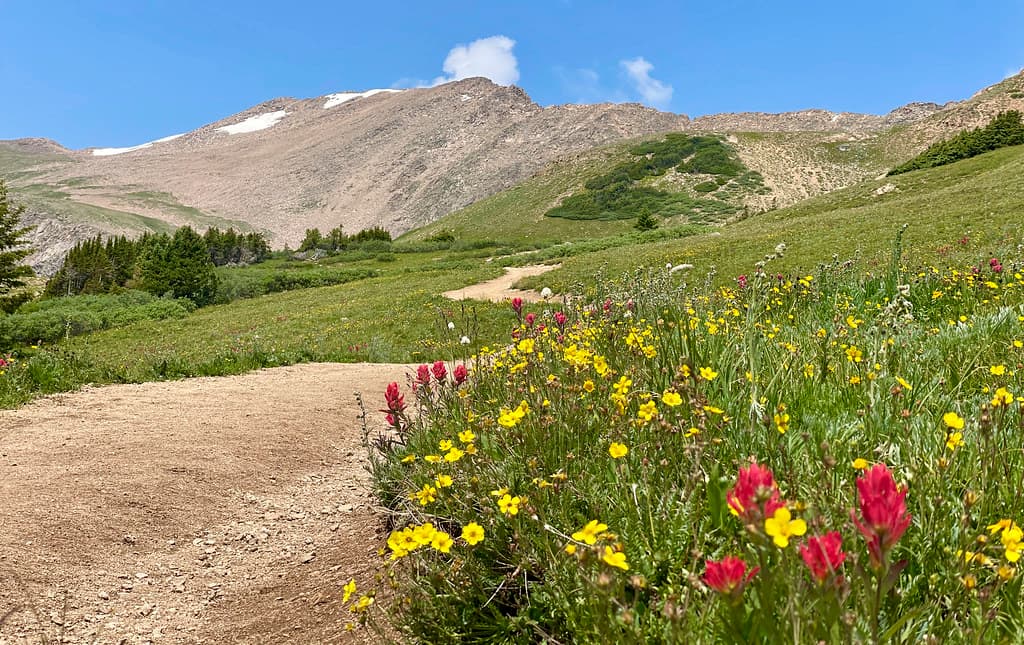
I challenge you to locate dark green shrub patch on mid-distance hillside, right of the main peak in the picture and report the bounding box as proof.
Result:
[546,133,760,221]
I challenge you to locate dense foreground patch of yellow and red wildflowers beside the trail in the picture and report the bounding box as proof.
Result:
[374,247,1024,643]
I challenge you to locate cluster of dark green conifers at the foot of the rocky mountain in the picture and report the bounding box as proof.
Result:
[44,226,270,305]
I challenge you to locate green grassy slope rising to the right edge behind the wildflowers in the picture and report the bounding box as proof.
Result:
[526,146,1024,288]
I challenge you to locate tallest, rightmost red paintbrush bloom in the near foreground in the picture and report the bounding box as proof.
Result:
[850,464,910,568]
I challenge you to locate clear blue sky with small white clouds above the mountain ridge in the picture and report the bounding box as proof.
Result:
[0,0,1024,147]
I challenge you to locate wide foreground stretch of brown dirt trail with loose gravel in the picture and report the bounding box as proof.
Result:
[0,364,409,645]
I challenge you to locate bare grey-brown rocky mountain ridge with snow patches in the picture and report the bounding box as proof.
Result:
[0,75,1024,272]
